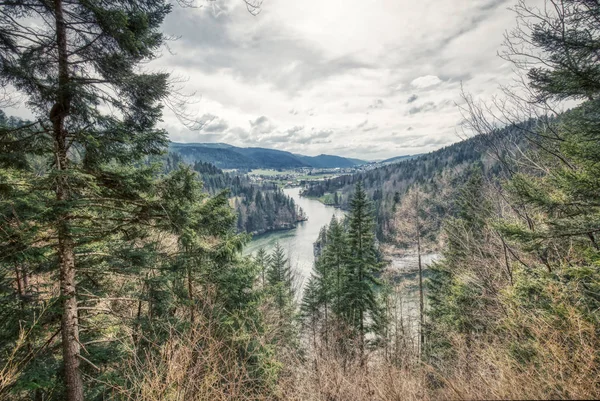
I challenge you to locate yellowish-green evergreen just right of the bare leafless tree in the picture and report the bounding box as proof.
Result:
[425,168,493,362]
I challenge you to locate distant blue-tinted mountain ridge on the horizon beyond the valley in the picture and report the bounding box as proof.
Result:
[169,142,366,169]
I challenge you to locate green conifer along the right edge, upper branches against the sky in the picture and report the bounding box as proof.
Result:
[502,0,600,271]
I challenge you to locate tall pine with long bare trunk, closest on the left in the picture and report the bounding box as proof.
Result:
[0,0,176,401]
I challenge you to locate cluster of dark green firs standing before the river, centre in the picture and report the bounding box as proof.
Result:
[302,184,383,355]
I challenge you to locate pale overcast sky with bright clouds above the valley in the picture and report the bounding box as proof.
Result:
[11,0,534,160]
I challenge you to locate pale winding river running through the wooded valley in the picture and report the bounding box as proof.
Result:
[244,188,345,285]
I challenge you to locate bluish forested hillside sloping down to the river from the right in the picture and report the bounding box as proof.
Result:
[303,120,536,242]
